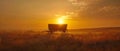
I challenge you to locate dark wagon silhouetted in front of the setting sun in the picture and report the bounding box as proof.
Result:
[48,24,67,33]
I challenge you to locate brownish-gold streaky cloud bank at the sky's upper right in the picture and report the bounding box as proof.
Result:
[69,0,120,18]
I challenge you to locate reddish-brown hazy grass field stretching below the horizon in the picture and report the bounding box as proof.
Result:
[0,28,120,51]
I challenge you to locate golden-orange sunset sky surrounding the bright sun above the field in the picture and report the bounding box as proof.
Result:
[0,0,120,30]
